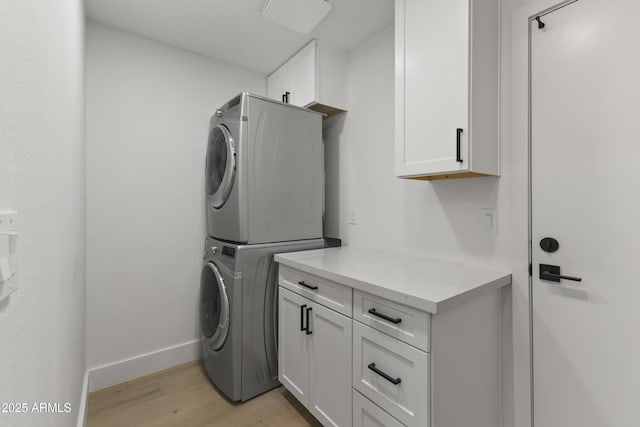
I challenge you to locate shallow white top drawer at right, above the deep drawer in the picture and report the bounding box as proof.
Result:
[353,290,431,351]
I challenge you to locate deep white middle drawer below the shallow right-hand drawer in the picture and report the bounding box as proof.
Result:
[353,322,430,427]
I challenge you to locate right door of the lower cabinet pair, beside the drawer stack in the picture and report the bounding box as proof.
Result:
[308,303,352,426]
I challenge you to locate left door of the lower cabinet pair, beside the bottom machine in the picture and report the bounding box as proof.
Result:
[278,287,311,406]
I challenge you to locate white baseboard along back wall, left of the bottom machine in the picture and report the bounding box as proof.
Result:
[89,340,202,392]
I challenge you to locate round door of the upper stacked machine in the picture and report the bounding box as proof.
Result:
[206,124,236,209]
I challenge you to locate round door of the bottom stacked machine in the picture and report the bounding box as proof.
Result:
[200,262,229,351]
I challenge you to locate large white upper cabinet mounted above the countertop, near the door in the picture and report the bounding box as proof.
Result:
[395,0,499,180]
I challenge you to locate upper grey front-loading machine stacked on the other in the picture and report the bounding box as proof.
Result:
[205,93,324,244]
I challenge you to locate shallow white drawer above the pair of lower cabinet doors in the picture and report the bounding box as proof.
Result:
[278,265,353,317]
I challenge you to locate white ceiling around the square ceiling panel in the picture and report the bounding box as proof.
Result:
[85,0,394,74]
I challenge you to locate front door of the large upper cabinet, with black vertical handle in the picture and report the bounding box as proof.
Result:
[396,0,471,176]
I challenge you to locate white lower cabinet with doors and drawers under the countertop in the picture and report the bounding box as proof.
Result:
[278,266,503,427]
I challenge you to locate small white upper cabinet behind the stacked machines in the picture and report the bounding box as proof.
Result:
[267,40,347,116]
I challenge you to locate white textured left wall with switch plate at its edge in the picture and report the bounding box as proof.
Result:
[0,0,85,427]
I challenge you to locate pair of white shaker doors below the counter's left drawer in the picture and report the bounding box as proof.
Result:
[278,287,352,426]
